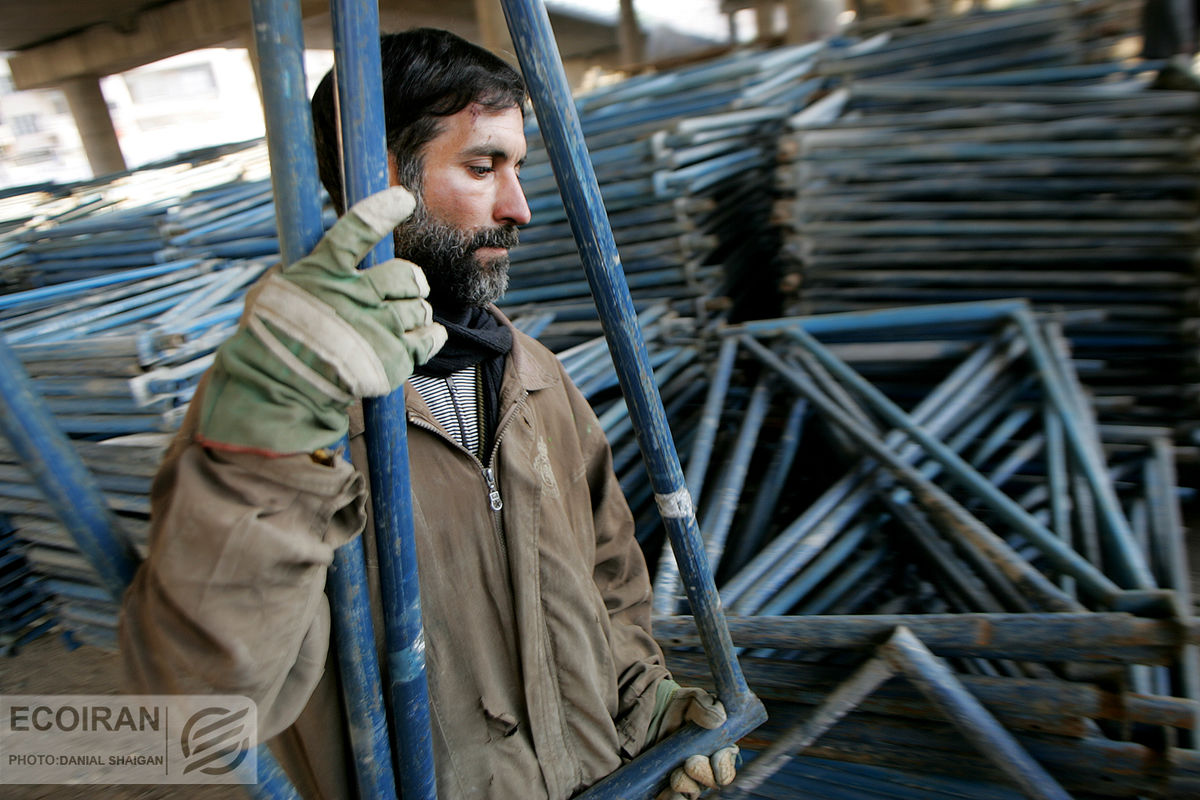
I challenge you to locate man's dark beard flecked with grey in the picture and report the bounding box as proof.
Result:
[392,199,517,309]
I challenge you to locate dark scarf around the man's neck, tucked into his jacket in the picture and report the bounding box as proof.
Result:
[416,307,512,459]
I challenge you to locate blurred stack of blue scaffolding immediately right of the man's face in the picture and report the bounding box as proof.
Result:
[502,38,824,350]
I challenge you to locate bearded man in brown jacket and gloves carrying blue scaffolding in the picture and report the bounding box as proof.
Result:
[121,30,736,800]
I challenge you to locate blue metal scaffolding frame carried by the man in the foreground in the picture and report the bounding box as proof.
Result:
[0,0,767,800]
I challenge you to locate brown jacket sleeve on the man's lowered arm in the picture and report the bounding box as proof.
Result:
[564,375,670,757]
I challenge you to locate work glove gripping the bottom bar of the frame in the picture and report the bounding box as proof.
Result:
[647,678,738,800]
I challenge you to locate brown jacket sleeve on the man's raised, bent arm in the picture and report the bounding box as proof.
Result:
[119,404,366,740]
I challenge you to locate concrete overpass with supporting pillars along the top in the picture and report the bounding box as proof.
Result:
[0,0,657,175]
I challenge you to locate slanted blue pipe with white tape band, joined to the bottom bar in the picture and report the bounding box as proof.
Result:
[502,0,766,798]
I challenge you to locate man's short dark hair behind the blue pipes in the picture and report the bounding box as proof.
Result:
[312,28,526,213]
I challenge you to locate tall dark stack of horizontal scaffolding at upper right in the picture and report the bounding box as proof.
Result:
[775,12,1200,437]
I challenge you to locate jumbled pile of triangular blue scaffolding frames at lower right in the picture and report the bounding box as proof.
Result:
[655,301,1200,798]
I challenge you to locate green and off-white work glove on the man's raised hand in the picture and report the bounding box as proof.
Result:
[197,187,446,456]
